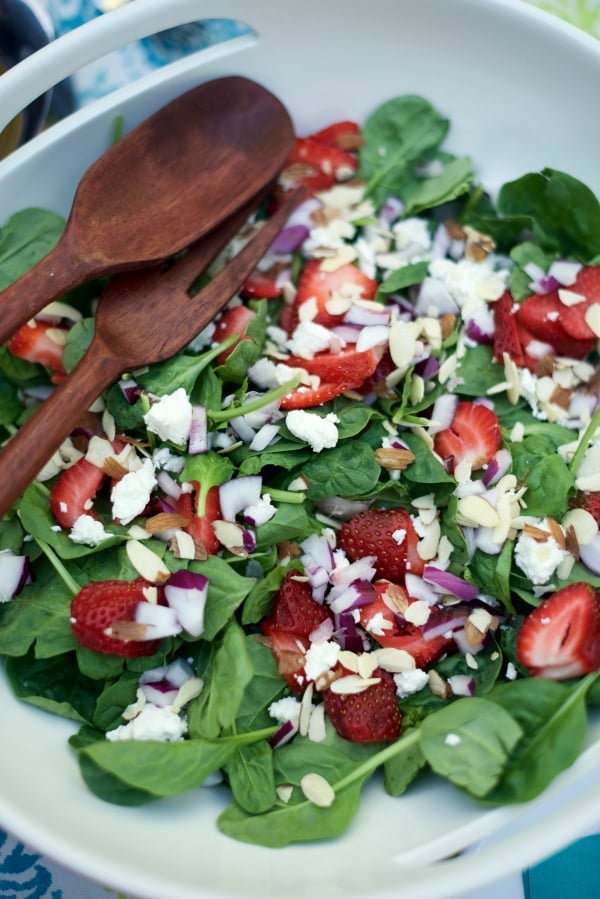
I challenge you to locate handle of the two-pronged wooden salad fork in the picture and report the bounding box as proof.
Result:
[0,346,122,518]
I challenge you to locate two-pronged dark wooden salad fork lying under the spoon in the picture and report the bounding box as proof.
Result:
[0,189,305,518]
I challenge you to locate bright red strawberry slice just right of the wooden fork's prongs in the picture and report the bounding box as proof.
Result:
[288,259,377,333]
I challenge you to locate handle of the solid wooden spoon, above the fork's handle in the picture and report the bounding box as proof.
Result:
[0,236,89,343]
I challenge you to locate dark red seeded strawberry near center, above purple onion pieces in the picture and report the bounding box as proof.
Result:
[338,509,425,584]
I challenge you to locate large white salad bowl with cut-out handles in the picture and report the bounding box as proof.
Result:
[0,0,600,899]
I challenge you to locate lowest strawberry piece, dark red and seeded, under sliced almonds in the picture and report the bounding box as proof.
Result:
[323,668,402,743]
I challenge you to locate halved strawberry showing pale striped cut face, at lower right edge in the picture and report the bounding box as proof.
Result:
[517,582,600,680]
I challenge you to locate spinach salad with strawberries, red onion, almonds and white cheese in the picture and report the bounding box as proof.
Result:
[0,94,600,848]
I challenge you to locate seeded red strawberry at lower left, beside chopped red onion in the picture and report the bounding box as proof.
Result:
[71,578,160,658]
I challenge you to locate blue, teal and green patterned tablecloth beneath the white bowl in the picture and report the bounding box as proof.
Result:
[0,0,600,899]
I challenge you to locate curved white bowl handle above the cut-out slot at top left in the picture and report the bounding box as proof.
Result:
[0,0,252,131]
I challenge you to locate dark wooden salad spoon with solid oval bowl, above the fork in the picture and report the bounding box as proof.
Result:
[0,76,294,343]
